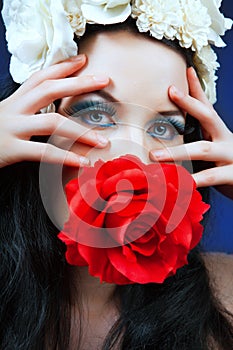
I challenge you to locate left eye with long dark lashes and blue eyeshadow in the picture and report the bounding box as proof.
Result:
[64,100,116,128]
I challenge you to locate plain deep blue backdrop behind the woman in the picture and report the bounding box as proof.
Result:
[0,0,233,253]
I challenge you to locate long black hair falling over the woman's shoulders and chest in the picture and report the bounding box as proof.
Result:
[0,17,233,350]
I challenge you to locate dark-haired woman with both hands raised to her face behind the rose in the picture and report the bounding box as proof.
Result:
[0,2,233,349]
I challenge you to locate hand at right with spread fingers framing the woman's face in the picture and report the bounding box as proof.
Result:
[150,68,233,199]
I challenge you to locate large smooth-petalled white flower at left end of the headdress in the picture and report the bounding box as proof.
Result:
[2,0,77,83]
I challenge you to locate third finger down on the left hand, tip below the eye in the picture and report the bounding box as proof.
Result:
[15,113,108,147]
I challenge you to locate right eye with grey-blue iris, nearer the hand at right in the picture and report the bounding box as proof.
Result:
[147,118,184,140]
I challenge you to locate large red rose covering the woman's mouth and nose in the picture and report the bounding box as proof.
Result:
[58,155,209,284]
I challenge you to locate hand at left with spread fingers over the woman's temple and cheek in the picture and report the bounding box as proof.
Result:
[0,55,109,168]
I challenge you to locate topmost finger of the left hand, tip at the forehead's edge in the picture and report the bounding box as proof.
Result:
[12,54,86,97]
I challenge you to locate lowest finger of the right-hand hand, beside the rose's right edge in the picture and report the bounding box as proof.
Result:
[192,164,233,187]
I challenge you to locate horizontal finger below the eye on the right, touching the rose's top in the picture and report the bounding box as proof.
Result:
[150,141,233,162]
